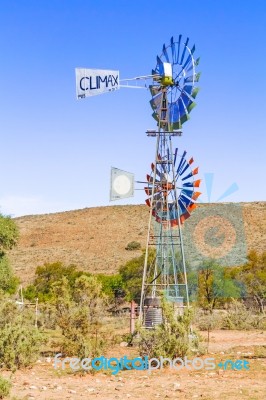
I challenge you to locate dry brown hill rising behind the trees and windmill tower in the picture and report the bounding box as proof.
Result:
[9,202,266,283]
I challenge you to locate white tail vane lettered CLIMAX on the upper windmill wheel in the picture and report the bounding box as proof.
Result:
[76,68,119,99]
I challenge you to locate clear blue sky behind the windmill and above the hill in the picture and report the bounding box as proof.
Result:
[0,0,266,216]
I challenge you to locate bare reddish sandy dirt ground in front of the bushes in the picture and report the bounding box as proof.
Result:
[3,330,266,400]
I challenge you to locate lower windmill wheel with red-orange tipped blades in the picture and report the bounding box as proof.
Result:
[144,149,201,227]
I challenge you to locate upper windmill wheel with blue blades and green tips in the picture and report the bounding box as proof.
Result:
[150,35,200,129]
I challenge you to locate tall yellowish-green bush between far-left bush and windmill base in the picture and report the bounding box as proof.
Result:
[53,275,106,358]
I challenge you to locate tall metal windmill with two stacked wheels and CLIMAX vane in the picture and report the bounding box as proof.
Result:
[76,35,200,328]
